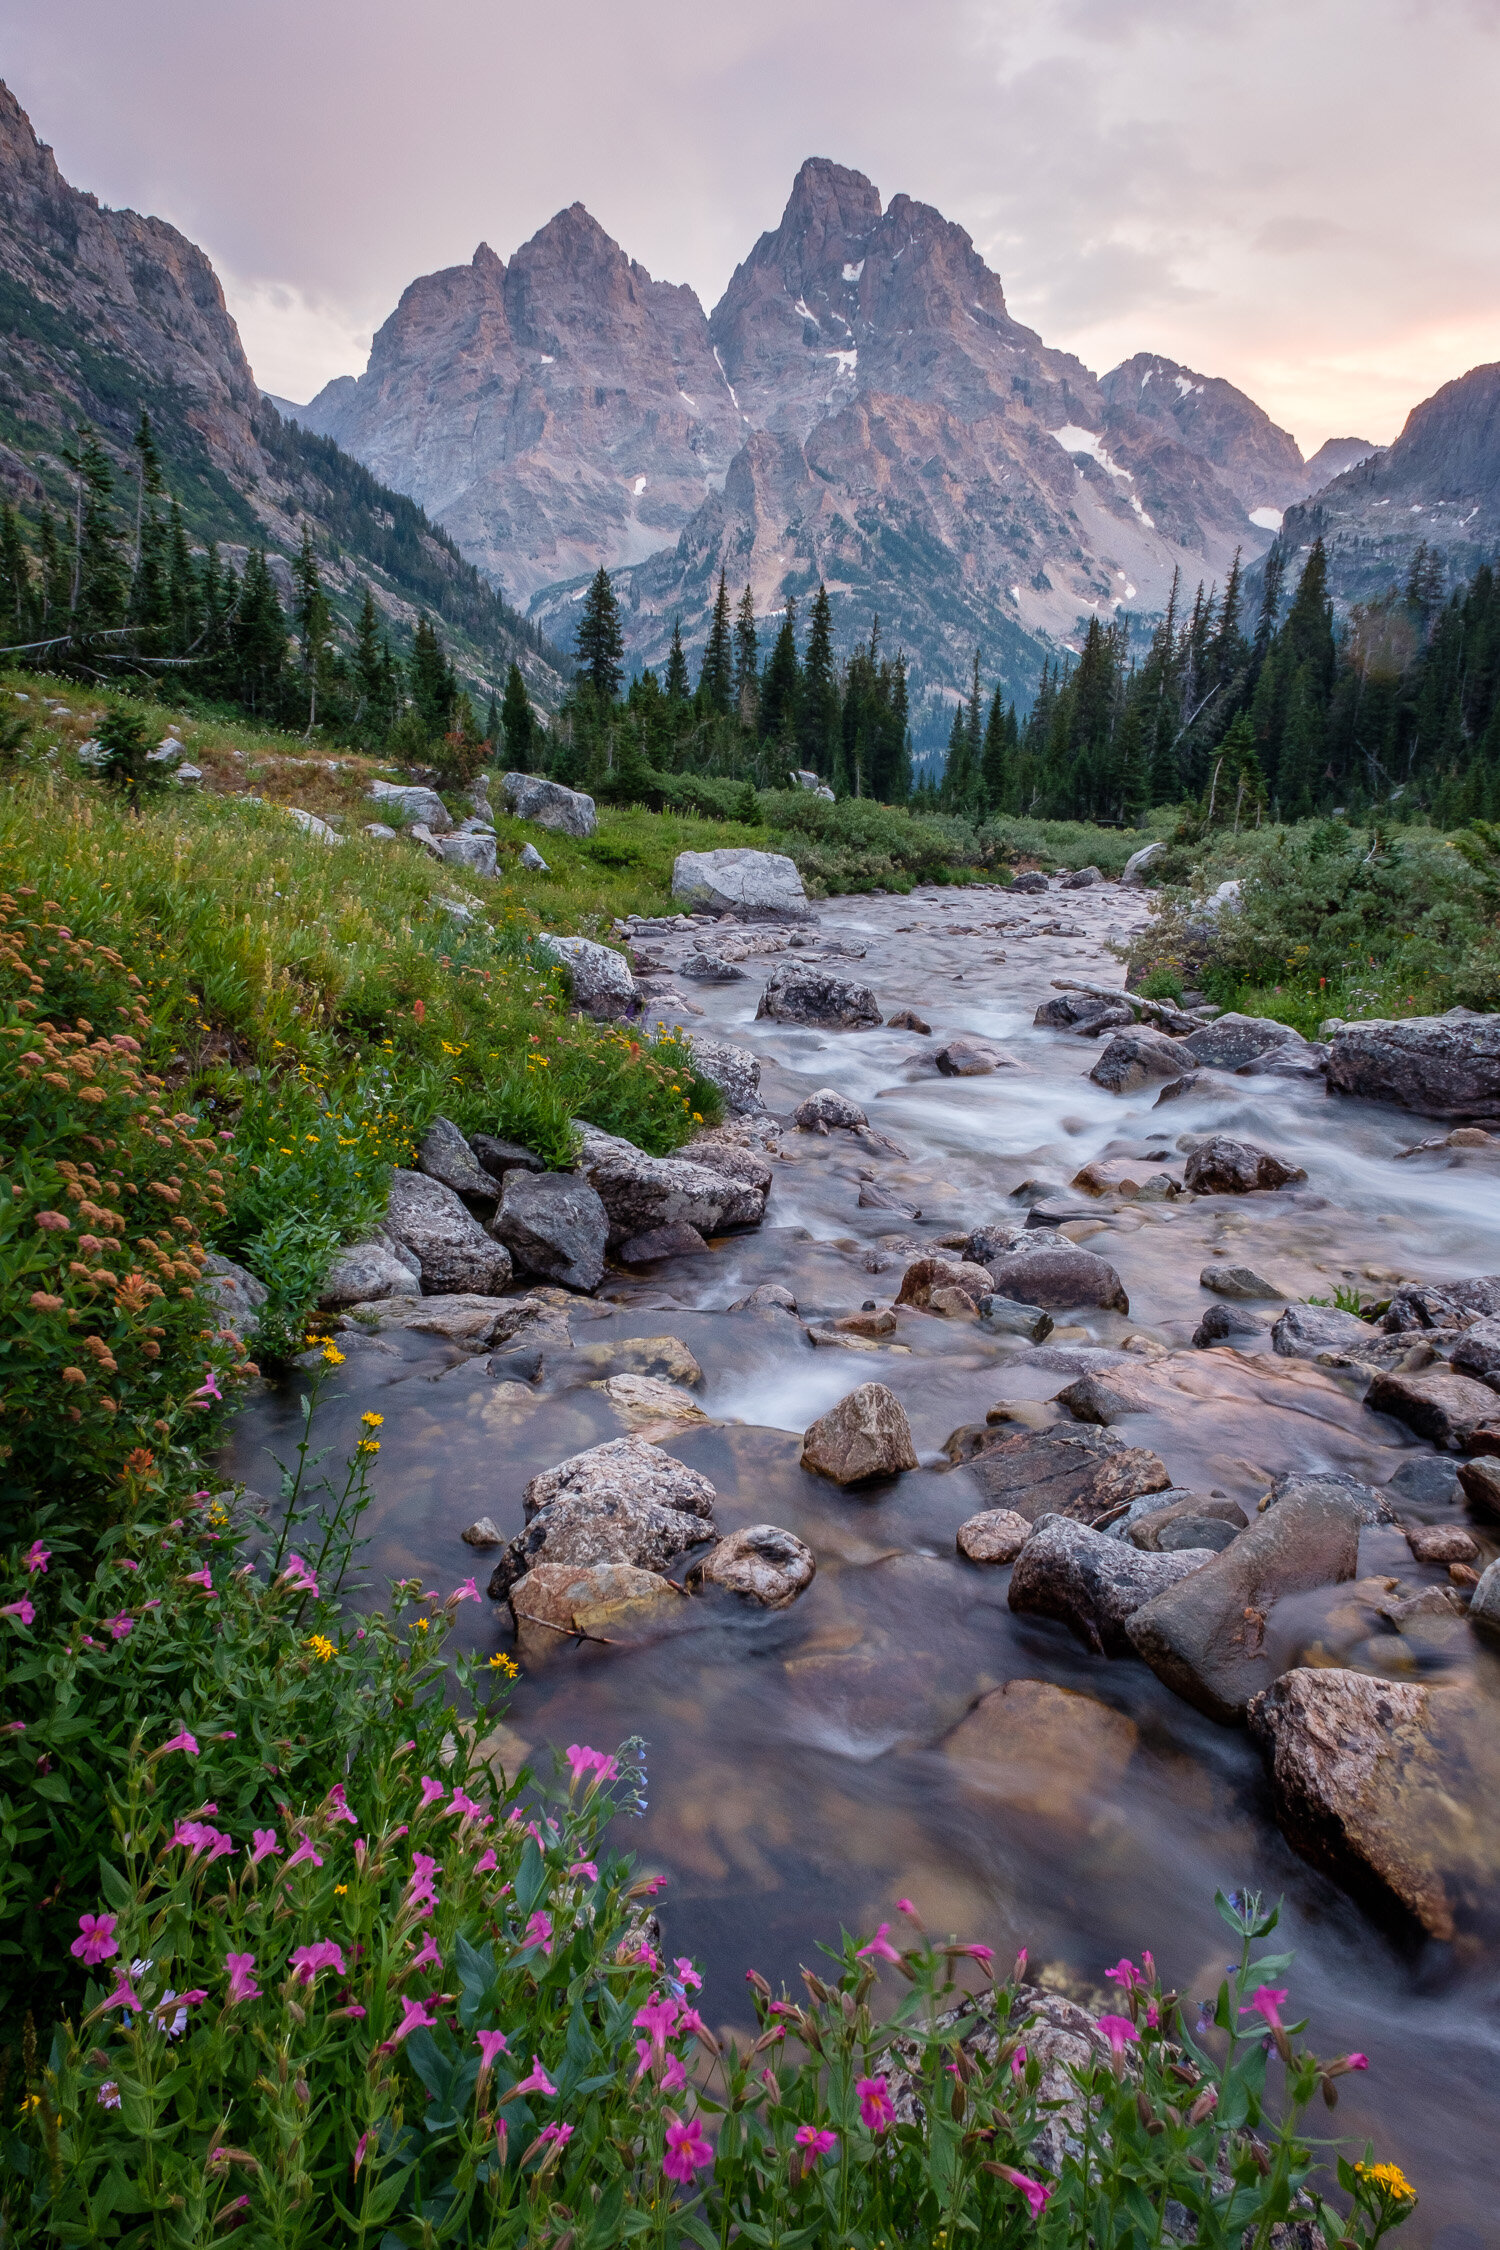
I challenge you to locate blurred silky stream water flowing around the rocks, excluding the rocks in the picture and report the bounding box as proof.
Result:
[227,884,1500,2250]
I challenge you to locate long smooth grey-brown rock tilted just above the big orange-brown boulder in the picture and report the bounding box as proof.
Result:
[1127,1492,1361,1726]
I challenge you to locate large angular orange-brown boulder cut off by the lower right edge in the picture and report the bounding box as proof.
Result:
[1248,1667,1500,1942]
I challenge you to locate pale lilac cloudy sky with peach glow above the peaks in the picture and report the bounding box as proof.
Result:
[0,0,1500,452]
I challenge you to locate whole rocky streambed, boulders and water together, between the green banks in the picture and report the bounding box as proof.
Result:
[229,884,1500,2250]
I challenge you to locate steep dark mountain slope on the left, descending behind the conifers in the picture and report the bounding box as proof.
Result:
[0,86,560,700]
